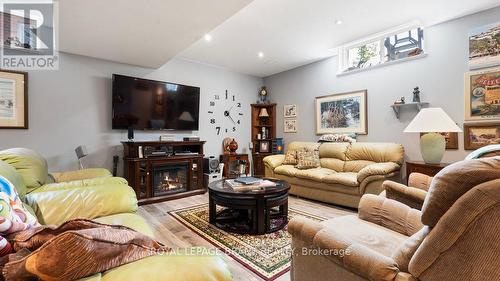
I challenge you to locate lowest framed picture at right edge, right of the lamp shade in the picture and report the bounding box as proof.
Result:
[464,122,500,150]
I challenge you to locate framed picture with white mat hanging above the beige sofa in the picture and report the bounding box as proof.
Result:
[316,90,368,135]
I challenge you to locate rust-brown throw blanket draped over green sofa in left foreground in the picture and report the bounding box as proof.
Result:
[0,219,170,281]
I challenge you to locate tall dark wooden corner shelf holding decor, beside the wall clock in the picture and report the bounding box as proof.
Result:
[251,103,276,176]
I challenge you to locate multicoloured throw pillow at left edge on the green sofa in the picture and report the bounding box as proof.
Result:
[0,176,39,235]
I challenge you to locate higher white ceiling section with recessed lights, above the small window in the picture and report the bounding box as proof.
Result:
[182,0,500,77]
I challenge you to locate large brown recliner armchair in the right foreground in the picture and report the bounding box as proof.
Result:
[288,157,500,281]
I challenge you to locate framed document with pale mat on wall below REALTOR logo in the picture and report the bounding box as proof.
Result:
[0,70,28,129]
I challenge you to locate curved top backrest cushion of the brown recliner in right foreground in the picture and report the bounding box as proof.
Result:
[422,156,500,227]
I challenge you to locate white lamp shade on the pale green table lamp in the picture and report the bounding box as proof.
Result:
[404,107,462,133]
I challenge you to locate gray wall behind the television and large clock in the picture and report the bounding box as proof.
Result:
[0,53,263,173]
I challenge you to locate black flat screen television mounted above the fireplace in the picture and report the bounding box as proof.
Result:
[112,74,200,131]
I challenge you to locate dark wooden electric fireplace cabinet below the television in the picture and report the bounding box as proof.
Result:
[122,141,206,205]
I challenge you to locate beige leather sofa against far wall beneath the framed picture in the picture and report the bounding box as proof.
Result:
[264,142,404,208]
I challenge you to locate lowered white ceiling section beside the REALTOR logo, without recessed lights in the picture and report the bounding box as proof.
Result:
[59,0,251,68]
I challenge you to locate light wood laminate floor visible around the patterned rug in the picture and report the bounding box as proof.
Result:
[138,194,355,281]
